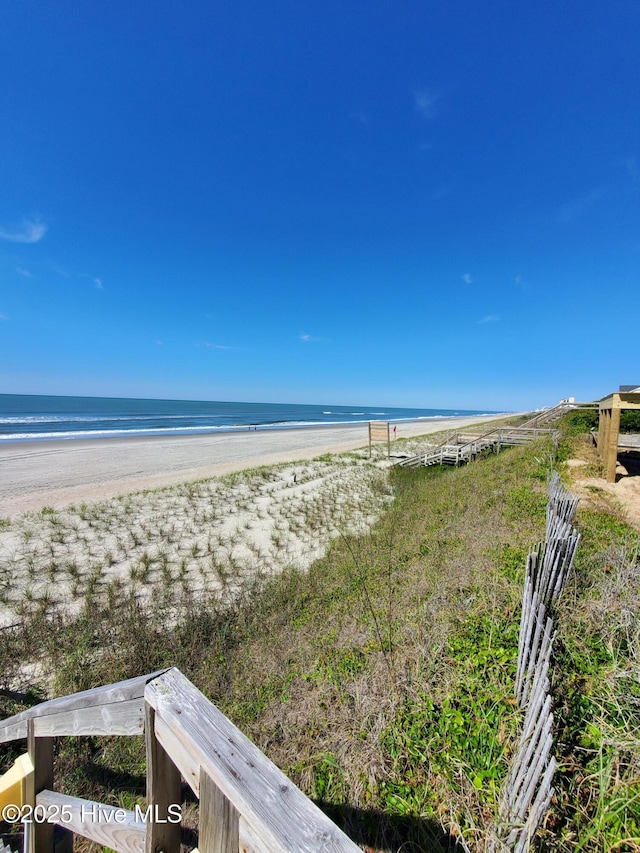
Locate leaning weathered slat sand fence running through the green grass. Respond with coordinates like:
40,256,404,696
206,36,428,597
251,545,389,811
494,472,580,853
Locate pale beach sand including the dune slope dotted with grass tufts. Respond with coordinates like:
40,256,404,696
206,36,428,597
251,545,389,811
0,416,512,627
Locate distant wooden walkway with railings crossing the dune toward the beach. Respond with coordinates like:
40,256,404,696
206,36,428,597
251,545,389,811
396,427,560,468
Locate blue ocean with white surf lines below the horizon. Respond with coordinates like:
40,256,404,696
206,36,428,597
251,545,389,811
0,394,500,442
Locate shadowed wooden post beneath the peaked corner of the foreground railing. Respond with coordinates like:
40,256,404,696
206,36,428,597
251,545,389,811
144,702,182,853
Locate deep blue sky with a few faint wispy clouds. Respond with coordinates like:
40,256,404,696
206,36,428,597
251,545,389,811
0,0,640,410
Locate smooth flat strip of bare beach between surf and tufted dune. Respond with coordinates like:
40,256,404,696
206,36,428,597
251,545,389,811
0,414,507,517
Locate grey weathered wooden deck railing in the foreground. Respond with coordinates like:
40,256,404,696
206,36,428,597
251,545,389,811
0,668,359,853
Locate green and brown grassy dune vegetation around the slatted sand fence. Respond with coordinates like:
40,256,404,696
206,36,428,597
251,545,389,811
0,422,640,853
